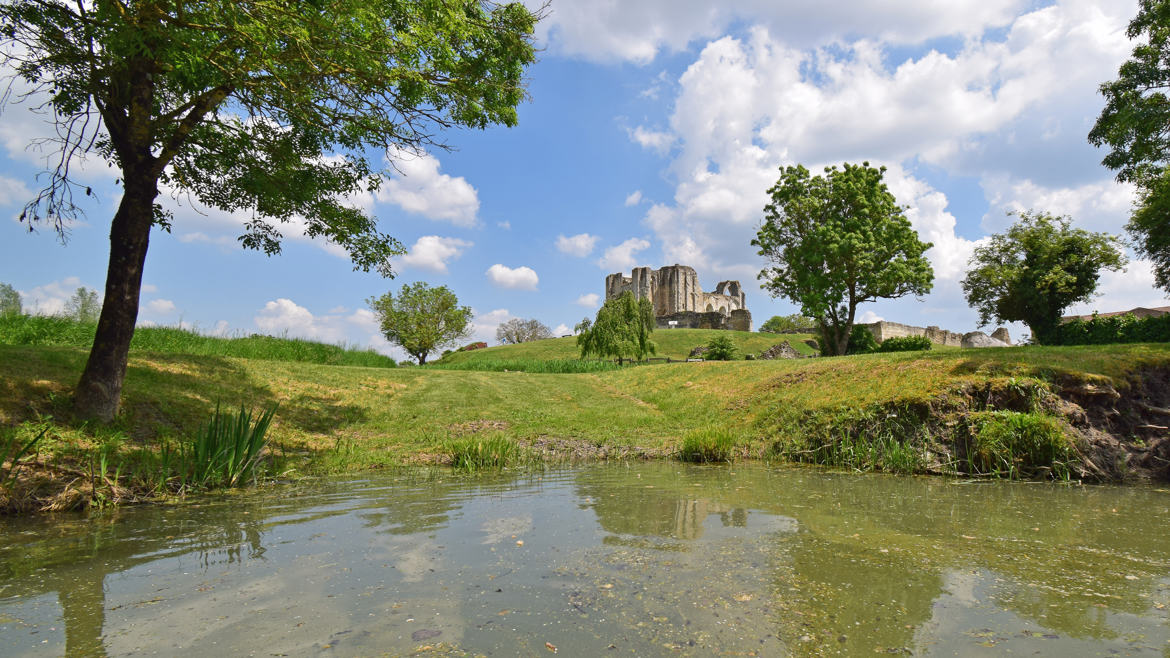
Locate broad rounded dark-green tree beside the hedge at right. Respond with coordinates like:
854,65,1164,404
963,211,1126,343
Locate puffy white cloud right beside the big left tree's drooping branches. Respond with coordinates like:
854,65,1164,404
377,150,480,226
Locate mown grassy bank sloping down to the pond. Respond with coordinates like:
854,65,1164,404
0,333,1170,507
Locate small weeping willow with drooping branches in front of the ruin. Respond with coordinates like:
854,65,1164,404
577,290,658,364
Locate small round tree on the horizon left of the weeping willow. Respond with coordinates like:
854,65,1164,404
366,281,472,365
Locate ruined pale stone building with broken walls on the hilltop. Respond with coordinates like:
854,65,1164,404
605,265,751,331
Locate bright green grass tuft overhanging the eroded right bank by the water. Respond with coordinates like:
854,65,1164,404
968,411,1076,480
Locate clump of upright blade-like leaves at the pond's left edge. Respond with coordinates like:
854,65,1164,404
183,405,276,487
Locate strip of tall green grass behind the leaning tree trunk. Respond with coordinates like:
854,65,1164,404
0,315,395,368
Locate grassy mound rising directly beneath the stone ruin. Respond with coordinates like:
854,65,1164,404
441,329,815,365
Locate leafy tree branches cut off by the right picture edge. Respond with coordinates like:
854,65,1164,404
1089,0,1170,290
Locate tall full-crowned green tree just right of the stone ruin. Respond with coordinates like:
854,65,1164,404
751,163,934,355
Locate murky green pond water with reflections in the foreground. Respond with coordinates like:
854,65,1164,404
0,464,1170,657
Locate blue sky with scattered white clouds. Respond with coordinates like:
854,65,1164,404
0,0,1170,358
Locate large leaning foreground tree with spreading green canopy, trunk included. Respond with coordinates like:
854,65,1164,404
0,0,538,419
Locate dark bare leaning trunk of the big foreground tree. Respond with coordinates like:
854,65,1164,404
74,176,158,423
